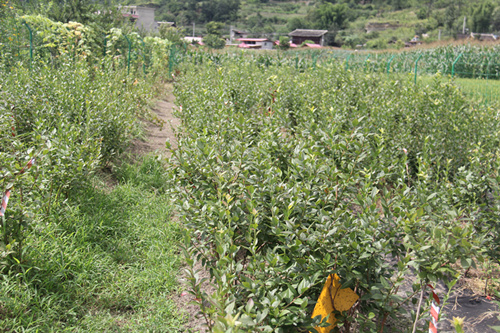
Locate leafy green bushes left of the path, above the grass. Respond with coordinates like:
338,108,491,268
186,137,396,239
0,56,156,264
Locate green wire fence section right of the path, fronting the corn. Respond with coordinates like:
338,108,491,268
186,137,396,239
196,44,500,104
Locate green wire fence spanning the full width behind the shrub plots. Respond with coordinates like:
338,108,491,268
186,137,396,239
0,13,500,104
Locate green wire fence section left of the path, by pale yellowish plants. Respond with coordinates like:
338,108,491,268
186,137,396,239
0,18,186,75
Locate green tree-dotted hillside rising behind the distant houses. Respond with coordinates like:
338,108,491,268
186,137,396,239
18,0,500,49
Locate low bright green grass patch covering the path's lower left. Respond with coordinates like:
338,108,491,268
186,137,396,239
0,157,184,332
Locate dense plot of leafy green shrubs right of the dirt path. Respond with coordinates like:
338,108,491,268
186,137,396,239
170,59,500,332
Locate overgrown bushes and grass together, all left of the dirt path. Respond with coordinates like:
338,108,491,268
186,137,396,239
0,1,188,332
